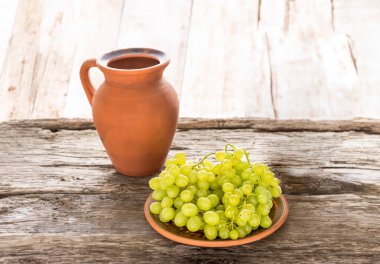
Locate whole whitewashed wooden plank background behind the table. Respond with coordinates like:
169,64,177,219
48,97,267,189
0,0,380,120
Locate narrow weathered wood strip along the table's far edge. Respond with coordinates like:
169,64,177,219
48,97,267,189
4,118,380,134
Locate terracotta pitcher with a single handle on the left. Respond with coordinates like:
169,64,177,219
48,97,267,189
80,48,178,176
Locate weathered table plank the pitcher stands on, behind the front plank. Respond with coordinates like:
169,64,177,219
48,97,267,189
0,119,380,197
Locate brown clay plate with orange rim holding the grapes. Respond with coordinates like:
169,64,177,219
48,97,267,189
144,195,289,247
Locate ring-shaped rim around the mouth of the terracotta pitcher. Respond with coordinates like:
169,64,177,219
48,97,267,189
96,48,170,74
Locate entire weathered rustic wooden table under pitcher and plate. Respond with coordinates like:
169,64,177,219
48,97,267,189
0,119,380,263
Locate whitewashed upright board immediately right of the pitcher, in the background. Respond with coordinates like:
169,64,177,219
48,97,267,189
180,0,274,118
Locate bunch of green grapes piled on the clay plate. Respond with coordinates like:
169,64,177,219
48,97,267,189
149,144,282,240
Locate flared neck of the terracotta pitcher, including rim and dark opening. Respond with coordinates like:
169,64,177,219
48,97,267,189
96,48,170,86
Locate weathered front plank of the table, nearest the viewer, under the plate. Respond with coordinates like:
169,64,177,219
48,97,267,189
0,194,380,263
